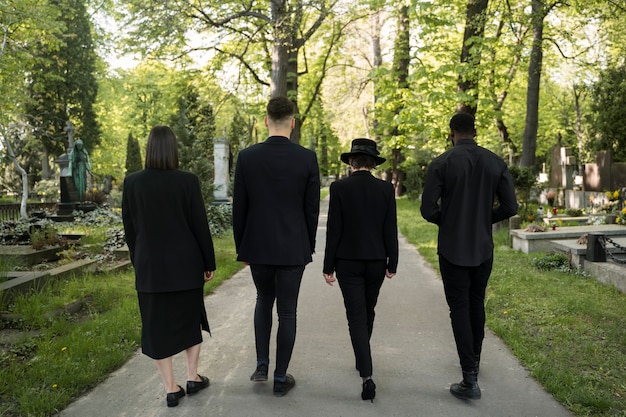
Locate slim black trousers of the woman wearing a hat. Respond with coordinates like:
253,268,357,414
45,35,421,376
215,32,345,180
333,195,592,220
335,259,386,377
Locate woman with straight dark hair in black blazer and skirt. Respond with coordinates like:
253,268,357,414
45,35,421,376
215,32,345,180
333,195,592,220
122,126,215,407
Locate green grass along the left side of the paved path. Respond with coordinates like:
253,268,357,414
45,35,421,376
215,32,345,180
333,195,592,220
0,235,242,416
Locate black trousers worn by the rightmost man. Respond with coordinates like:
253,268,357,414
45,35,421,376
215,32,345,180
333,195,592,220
439,255,493,372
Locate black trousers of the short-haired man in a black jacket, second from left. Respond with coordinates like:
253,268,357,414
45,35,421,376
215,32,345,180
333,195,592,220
250,265,304,378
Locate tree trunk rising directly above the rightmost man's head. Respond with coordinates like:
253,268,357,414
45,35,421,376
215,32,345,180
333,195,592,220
457,0,489,115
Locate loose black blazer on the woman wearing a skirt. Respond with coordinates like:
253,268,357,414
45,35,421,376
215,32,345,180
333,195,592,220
122,169,215,292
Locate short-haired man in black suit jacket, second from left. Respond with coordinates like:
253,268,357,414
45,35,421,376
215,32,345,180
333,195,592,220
233,97,320,397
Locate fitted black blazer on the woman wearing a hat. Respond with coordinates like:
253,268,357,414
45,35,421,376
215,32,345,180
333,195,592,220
323,171,398,274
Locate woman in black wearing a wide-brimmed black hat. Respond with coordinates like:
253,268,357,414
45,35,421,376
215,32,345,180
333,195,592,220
323,138,398,401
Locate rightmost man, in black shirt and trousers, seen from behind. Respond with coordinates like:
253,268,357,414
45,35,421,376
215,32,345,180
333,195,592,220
421,113,518,400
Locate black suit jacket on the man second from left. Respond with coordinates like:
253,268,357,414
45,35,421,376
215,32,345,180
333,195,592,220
233,136,320,265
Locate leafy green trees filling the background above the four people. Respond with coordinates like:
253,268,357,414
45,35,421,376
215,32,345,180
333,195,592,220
0,0,626,205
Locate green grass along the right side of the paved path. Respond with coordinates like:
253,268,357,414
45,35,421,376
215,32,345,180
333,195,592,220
398,199,626,416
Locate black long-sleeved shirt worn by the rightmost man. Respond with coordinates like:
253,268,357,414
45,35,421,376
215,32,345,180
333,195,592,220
420,139,517,267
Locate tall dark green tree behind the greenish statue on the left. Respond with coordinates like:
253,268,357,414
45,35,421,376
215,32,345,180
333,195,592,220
26,0,100,178
